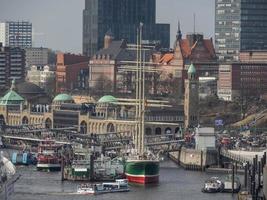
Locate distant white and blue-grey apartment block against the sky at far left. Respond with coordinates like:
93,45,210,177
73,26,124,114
0,21,32,48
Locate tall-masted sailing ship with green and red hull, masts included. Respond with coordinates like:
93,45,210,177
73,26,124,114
125,23,159,184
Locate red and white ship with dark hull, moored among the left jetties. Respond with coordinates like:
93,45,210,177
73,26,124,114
37,140,61,171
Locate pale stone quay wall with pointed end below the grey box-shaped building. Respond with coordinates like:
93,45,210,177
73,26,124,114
169,148,217,170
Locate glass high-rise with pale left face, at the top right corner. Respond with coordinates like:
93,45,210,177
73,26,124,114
215,0,267,61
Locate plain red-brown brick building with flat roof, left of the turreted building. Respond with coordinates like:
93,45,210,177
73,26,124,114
56,53,89,92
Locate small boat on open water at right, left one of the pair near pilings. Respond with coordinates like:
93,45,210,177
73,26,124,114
202,177,224,193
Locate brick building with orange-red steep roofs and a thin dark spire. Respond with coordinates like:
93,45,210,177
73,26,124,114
159,26,218,95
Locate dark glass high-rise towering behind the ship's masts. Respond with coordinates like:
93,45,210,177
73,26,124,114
83,0,170,56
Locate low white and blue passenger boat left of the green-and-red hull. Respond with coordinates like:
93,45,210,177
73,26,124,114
77,179,130,194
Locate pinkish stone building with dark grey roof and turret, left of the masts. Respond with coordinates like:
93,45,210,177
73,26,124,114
89,32,140,93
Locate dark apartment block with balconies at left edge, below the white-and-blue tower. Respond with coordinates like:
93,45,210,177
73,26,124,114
0,43,25,88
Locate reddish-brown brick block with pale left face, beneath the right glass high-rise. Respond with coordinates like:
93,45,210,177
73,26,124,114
218,51,267,101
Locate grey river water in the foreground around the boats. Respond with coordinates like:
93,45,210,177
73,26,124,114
12,161,240,200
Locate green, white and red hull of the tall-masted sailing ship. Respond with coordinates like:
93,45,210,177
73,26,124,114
125,159,159,184
